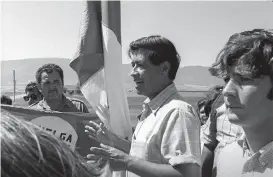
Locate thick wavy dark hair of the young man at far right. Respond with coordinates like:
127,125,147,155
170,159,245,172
210,29,273,81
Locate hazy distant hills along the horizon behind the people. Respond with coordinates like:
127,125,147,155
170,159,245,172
1,58,223,90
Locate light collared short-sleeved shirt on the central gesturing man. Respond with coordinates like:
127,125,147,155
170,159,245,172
127,84,201,177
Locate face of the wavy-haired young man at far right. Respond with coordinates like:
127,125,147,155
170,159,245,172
223,74,273,127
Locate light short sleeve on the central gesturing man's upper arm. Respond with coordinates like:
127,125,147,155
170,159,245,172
161,106,201,166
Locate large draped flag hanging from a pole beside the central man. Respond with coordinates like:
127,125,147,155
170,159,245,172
70,1,132,139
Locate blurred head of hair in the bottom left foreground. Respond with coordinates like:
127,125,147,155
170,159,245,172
0,111,104,177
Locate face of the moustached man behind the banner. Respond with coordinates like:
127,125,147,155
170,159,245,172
40,70,63,101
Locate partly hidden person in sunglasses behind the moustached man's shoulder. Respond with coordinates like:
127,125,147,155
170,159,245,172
23,82,43,106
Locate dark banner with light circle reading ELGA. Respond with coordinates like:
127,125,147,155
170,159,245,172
1,105,100,157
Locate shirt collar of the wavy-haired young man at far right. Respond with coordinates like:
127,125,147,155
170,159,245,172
237,136,273,167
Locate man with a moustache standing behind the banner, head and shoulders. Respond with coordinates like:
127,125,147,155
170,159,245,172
29,64,88,113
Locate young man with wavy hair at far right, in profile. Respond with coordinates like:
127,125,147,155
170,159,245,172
209,29,273,177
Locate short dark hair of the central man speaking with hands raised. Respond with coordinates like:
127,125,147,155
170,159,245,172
128,35,180,80
